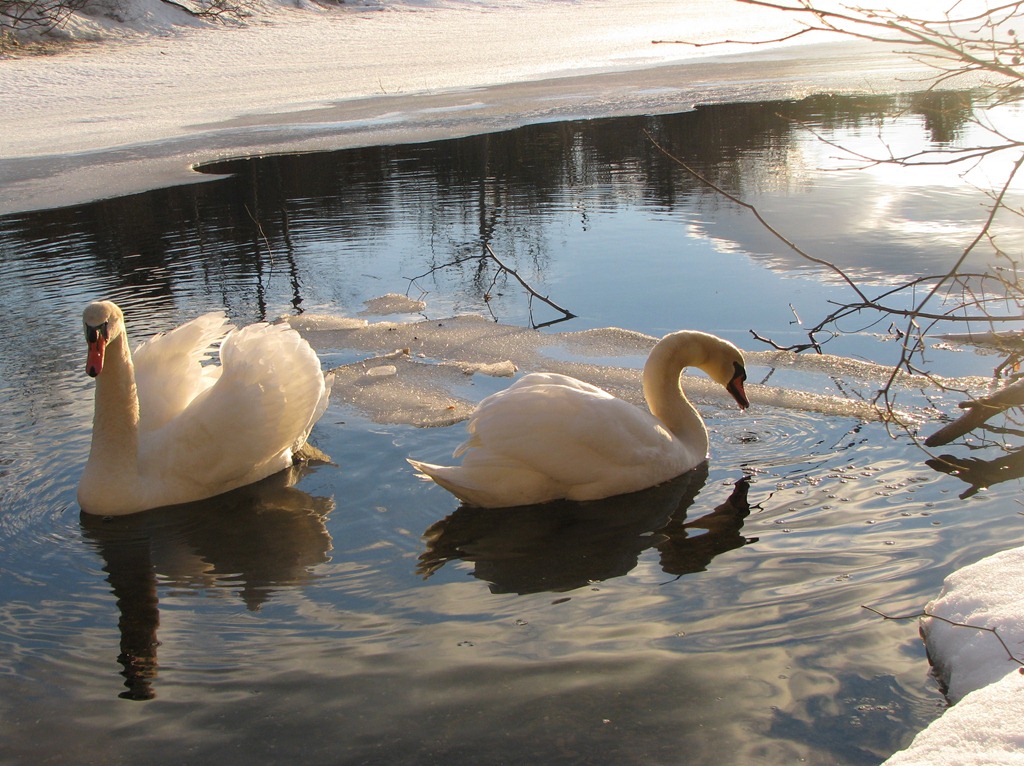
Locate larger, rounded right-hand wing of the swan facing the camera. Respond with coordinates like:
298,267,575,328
140,325,325,494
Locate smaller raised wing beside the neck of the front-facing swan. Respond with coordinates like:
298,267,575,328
132,311,233,431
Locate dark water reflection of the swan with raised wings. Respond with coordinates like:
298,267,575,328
81,464,334,699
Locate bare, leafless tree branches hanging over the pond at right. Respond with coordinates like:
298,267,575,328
648,0,1024,444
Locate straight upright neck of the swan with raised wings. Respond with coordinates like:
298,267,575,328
87,332,138,481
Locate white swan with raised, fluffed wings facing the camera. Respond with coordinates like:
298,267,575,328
78,301,331,516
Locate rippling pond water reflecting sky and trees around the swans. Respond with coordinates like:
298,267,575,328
0,93,1024,764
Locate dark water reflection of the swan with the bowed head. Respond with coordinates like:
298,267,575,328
417,464,756,594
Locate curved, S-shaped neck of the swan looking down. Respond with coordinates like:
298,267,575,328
643,333,709,455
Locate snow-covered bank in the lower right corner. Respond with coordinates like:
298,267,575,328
886,548,1024,766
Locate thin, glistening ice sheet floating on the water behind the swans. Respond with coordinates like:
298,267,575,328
289,303,966,426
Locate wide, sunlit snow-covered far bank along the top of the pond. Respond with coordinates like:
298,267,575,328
0,0,921,214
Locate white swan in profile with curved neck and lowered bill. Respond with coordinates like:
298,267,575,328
409,331,749,508
